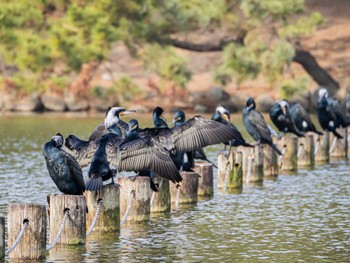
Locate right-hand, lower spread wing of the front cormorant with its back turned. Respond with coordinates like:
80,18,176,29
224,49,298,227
107,137,182,183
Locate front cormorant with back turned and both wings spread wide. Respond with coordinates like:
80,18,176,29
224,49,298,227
65,133,182,191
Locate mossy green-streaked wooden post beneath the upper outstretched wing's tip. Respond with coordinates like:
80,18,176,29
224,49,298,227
218,150,243,191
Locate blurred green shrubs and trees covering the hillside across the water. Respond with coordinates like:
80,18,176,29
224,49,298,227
0,0,322,99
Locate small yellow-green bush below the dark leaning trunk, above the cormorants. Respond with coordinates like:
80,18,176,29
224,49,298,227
278,76,310,99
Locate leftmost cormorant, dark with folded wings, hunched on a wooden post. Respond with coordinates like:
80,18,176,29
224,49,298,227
44,133,85,195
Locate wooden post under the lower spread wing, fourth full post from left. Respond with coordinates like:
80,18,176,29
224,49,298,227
118,176,152,223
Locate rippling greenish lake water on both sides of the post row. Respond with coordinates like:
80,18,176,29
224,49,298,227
0,115,350,262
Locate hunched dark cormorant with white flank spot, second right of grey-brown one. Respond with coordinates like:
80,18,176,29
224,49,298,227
289,102,323,135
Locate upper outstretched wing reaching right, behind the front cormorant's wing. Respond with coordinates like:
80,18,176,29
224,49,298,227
166,116,236,152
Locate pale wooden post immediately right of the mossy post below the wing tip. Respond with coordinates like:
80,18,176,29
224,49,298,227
237,145,264,183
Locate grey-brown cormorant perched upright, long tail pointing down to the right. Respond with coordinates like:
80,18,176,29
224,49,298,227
242,98,282,155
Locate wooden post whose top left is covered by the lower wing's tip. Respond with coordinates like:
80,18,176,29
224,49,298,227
170,172,199,205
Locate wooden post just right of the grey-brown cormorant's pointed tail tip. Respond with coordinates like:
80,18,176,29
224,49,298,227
277,134,298,172
